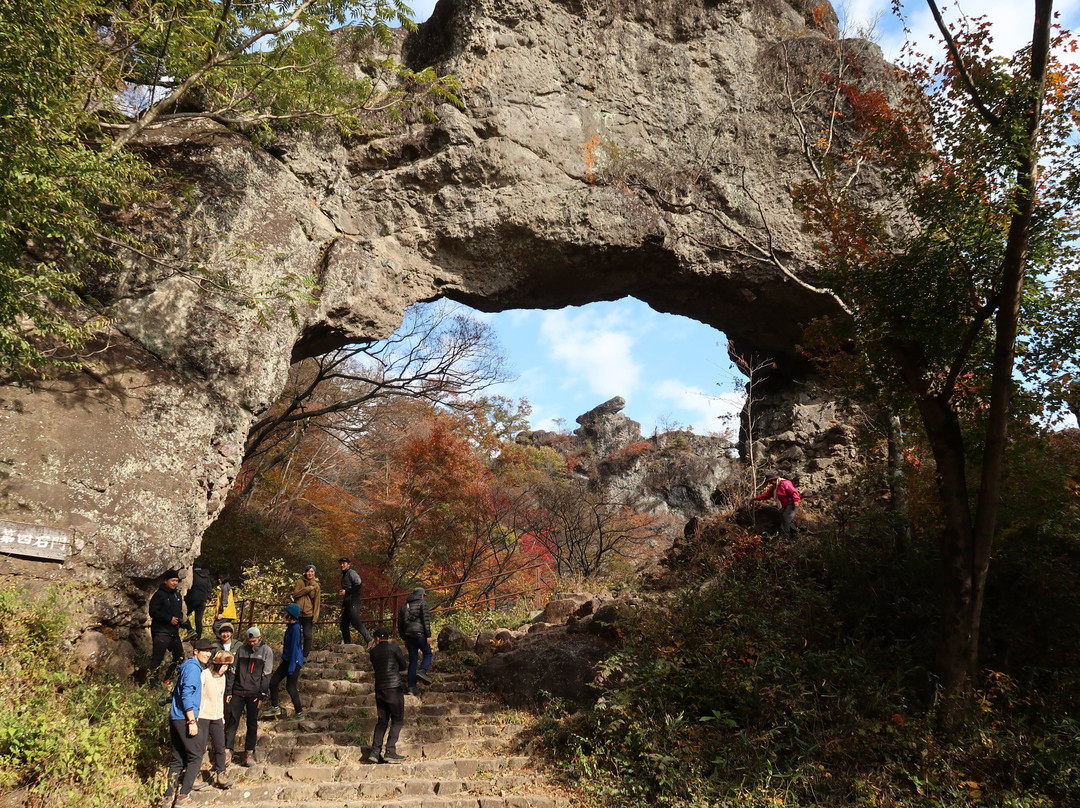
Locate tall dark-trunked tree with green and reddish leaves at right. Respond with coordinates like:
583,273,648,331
799,0,1080,731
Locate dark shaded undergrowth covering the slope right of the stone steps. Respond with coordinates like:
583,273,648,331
539,518,1080,808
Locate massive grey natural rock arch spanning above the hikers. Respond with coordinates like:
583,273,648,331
0,0,886,658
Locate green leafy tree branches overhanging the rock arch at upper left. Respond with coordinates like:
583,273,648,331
0,0,460,377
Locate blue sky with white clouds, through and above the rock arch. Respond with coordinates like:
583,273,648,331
413,0,1080,434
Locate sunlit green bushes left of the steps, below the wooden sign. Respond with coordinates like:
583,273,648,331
0,587,167,807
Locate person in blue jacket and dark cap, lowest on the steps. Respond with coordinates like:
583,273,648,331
162,639,214,806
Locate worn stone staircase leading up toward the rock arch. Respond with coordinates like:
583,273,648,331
185,645,570,808
